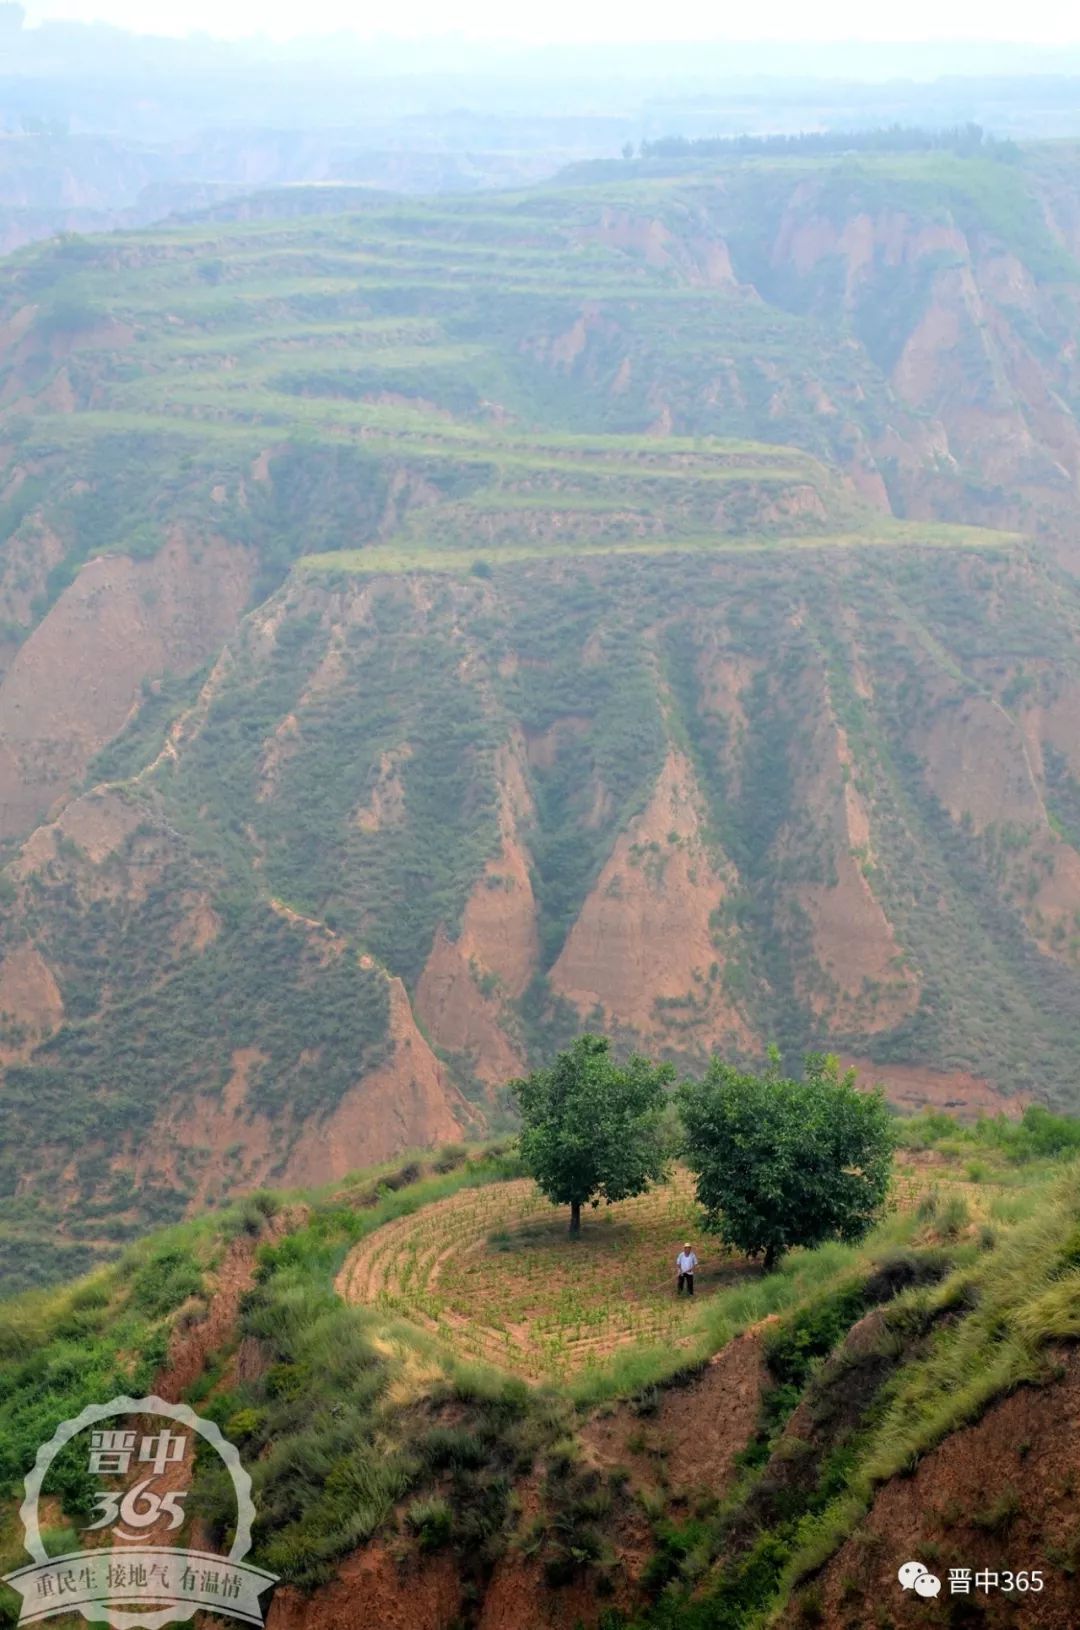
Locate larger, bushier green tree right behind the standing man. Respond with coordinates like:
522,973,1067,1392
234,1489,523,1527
679,1053,894,1271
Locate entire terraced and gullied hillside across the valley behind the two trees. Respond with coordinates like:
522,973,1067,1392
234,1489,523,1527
0,150,1080,1283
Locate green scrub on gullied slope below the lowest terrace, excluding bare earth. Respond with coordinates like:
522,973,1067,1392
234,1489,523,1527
10,547,1080,1283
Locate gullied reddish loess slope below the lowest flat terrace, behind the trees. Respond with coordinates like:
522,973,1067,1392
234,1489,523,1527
0,534,1080,1284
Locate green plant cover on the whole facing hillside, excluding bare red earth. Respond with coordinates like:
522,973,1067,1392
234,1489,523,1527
0,140,1080,1283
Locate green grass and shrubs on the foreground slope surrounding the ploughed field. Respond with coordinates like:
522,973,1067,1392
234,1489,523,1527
0,1112,1080,1630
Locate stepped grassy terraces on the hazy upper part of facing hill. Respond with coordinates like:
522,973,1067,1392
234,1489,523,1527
0,155,1049,592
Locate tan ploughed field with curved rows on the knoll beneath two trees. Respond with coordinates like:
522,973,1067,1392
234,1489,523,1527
336,1134,1049,1384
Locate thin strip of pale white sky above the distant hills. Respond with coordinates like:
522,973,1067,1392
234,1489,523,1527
23,0,1080,44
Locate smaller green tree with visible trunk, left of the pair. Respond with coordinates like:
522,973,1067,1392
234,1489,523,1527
510,1035,674,1234
